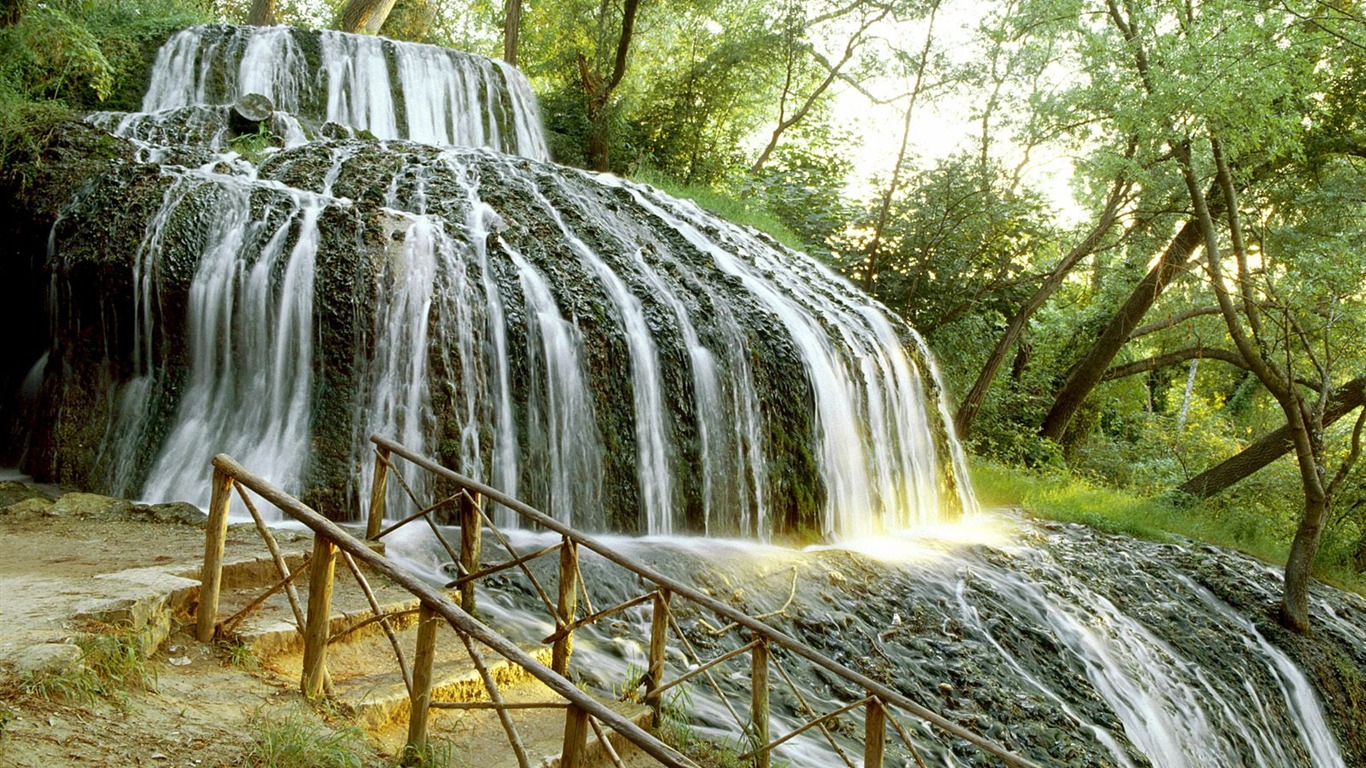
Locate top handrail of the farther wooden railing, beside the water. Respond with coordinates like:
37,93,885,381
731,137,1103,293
374,435,1041,768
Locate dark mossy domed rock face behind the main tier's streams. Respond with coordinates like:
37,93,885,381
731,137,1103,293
11,101,947,541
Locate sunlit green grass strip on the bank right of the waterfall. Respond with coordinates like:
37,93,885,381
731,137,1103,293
971,459,1366,596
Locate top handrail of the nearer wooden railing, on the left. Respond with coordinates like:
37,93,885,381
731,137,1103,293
213,454,699,768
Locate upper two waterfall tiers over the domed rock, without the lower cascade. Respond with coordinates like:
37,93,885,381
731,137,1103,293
49,26,974,538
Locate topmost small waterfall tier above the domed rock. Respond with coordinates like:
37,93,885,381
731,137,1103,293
129,26,549,160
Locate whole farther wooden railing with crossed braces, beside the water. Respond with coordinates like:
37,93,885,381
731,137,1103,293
363,435,1037,768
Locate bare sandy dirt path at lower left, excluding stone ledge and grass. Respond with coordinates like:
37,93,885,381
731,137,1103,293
0,481,389,768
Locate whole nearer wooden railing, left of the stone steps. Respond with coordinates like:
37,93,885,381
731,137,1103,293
195,454,698,768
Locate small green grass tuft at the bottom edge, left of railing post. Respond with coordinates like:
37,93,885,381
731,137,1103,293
246,712,370,768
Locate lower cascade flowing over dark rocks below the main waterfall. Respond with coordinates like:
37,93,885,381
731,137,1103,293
391,512,1366,768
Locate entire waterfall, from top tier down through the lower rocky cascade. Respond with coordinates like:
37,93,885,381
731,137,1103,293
15,26,1366,768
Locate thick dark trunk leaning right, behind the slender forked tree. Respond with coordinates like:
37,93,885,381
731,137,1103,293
1040,219,1201,443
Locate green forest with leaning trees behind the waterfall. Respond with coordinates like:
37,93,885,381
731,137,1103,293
0,0,1366,629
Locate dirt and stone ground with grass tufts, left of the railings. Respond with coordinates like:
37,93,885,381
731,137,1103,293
0,480,654,768
